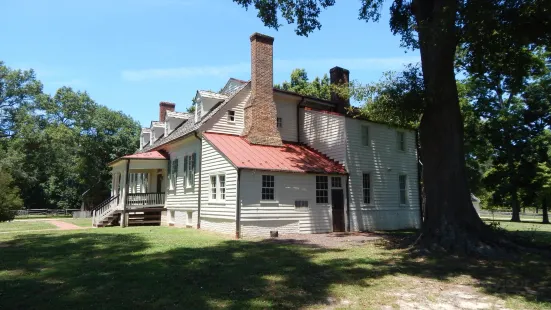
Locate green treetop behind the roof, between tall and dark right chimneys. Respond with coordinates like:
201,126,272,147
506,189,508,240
274,69,331,100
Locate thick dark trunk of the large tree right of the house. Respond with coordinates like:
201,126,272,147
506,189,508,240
413,0,485,253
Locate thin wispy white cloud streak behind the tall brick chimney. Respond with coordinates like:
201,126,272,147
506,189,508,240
121,56,419,82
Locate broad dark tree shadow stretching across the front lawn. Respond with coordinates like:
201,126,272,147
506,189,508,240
0,232,551,309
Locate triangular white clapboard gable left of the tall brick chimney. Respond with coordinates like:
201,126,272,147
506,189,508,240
203,86,251,135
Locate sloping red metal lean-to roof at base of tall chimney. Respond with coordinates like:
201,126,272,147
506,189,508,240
203,133,346,174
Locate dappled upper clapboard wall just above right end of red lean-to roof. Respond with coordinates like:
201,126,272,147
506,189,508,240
299,109,346,164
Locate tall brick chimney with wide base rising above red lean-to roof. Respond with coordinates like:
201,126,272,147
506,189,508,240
244,32,283,146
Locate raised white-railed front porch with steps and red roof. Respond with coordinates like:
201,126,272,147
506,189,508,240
92,151,168,227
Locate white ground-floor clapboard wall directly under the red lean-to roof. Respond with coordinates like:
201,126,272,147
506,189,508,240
240,170,346,237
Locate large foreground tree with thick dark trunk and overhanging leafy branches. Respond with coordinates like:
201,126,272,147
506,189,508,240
234,0,551,253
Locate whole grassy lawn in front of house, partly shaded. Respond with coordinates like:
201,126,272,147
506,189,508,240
0,227,551,309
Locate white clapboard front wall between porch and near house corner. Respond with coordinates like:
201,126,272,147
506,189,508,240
164,136,201,227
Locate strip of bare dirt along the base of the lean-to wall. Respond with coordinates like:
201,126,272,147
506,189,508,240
263,232,382,248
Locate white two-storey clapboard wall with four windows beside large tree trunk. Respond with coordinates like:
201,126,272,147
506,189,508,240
346,118,420,231
